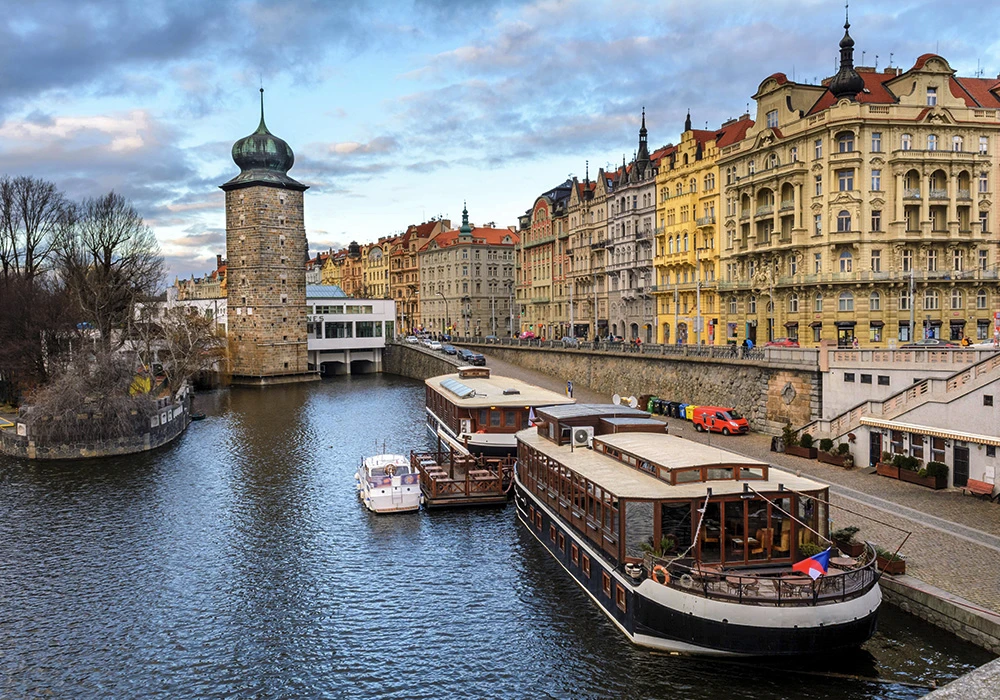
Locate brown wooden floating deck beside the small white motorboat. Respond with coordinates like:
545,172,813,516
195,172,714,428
410,450,514,508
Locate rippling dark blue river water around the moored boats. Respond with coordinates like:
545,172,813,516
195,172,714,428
0,375,991,699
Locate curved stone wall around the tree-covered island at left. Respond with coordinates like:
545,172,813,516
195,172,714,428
0,399,191,460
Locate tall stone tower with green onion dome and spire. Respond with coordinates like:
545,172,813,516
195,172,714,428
221,88,319,384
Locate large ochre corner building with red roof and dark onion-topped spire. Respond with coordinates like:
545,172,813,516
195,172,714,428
719,23,1000,346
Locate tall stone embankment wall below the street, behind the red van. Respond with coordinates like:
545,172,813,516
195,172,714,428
463,343,823,434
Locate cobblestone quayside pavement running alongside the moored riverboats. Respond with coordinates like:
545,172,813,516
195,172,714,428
478,358,1000,613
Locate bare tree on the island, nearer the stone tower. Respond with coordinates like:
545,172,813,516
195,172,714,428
58,192,163,350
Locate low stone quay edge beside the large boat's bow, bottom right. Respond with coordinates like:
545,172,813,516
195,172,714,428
879,576,1000,654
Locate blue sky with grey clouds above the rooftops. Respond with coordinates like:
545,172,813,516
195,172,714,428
0,0,1000,281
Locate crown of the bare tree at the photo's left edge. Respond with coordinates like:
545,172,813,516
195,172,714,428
0,176,73,282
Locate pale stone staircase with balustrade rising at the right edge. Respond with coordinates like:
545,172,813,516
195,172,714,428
796,353,1000,440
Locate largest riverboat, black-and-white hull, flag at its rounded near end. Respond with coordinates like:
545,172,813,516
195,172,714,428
515,405,882,656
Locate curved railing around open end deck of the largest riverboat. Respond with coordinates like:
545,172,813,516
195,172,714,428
643,544,878,607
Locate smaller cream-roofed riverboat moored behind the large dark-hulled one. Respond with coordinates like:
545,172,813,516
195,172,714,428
425,367,575,458
